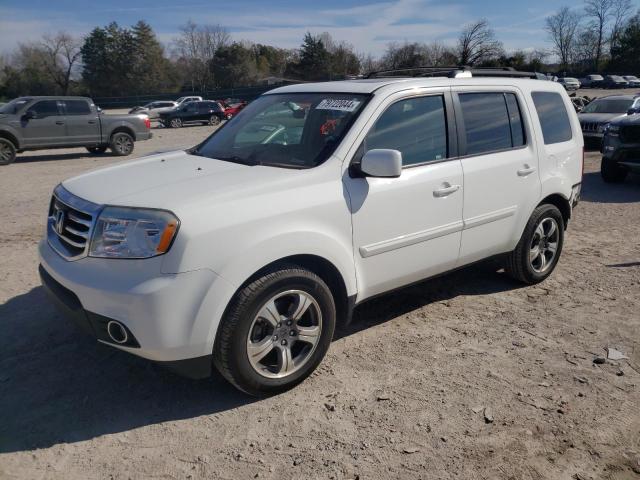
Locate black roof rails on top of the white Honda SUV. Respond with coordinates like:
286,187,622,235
366,65,546,79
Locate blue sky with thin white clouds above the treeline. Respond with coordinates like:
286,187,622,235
0,0,640,55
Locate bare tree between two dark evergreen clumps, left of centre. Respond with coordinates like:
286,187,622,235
174,20,231,91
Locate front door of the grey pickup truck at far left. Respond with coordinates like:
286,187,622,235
20,100,67,148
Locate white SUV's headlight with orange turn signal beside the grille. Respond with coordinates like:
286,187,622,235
89,207,180,258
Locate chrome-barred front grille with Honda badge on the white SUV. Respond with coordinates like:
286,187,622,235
47,185,101,260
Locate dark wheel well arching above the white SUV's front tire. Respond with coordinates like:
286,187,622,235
238,255,351,322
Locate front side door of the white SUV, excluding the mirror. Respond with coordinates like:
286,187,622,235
344,91,464,300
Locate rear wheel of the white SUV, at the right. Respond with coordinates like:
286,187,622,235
505,204,564,285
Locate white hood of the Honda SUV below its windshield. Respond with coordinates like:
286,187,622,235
62,151,300,211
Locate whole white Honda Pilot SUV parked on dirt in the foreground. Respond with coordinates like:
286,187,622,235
39,72,583,395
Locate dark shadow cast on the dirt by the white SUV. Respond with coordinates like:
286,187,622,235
0,262,519,452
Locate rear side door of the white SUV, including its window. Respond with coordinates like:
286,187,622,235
453,87,541,265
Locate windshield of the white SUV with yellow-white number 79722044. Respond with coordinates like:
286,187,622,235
191,93,368,168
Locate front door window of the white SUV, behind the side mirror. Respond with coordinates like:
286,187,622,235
364,95,447,165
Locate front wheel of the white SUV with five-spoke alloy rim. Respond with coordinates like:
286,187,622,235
213,266,336,396
